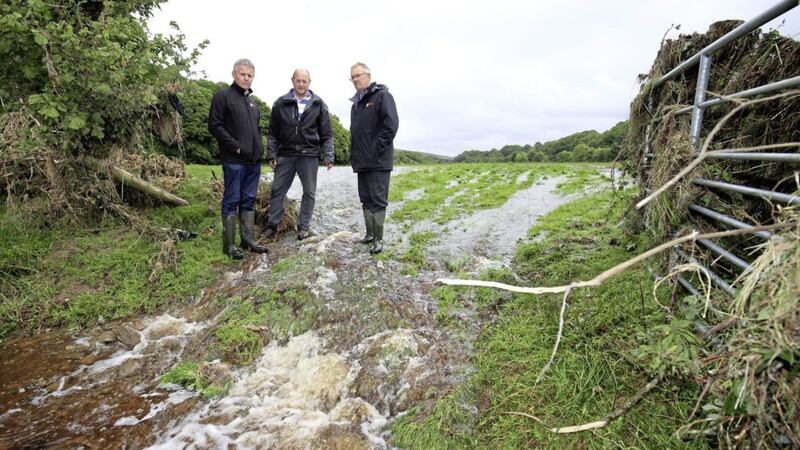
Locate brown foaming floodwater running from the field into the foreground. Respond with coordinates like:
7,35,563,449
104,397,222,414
0,168,580,449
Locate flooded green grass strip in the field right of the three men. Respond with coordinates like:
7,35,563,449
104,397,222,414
389,163,608,225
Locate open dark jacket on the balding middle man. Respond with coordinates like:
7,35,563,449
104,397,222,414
267,91,333,164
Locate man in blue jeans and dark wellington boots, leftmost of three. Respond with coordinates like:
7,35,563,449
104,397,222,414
208,59,267,259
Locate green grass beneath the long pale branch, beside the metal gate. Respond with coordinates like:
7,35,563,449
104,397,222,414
392,192,707,449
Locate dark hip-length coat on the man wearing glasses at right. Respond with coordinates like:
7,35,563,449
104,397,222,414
350,83,399,172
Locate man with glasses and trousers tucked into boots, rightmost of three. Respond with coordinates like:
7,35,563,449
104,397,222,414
350,63,399,254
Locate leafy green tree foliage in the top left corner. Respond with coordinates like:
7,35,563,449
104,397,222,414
0,0,207,156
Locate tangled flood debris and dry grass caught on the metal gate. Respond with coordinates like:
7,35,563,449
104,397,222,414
626,21,800,448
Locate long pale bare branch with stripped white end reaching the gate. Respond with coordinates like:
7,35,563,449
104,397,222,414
436,222,800,294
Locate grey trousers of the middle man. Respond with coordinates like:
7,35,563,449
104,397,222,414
267,156,319,230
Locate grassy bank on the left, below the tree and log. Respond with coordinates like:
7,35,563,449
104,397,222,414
0,166,244,339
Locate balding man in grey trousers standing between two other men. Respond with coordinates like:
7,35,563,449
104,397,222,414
264,69,333,240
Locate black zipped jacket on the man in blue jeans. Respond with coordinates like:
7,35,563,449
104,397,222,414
208,83,264,164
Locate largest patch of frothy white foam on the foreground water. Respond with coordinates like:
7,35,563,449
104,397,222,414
150,331,386,450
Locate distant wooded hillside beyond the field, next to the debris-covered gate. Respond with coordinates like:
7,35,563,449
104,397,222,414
453,120,628,162
